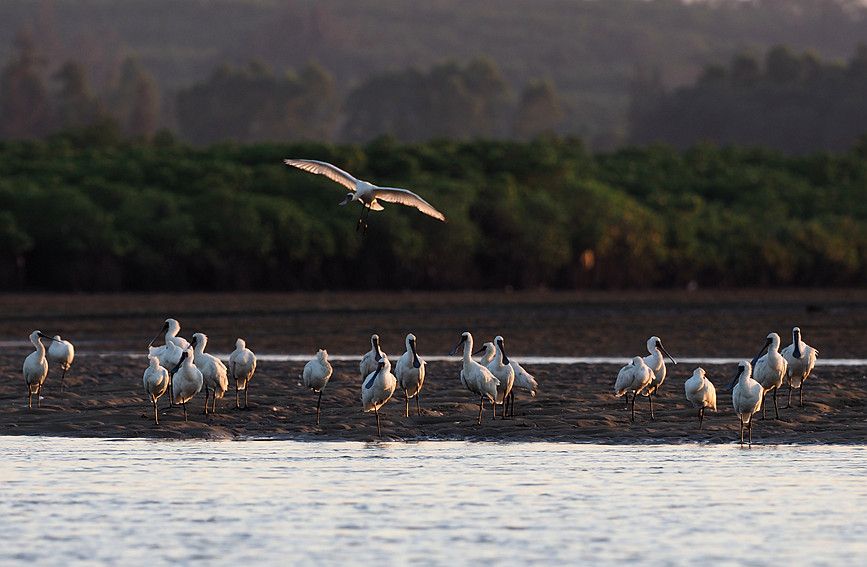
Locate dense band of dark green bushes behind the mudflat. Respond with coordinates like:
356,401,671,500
0,130,867,290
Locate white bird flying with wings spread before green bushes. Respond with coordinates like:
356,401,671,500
283,159,446,234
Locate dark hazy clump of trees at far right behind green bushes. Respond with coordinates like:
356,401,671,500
629,43,867,153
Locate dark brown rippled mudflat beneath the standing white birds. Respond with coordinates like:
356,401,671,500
0,292,867,444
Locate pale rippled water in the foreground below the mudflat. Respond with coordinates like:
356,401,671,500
0,437,867,566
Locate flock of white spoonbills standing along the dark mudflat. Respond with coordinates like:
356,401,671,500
23,318,819,444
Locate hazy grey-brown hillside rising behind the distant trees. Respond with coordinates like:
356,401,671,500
0,0,867,149
